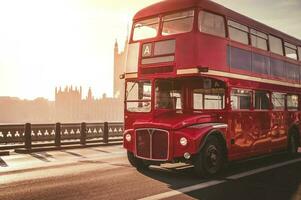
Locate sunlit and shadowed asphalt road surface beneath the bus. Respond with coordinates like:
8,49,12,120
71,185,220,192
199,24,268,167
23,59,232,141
0,146,301,200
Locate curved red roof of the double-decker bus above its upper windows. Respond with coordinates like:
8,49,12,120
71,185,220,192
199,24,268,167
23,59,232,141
134,0,301,46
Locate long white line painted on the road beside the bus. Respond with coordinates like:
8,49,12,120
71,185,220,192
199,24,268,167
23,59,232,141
139,158,301,200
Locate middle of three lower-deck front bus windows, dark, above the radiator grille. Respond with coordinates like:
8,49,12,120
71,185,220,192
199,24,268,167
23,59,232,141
155,80,182,110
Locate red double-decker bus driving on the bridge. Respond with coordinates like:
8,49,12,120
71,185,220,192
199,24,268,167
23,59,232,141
124,0,301,176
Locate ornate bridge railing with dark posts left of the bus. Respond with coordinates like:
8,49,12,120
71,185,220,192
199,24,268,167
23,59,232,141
0,122,123,150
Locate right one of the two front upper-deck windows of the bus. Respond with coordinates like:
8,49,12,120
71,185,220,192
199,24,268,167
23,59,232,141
162,10,194,36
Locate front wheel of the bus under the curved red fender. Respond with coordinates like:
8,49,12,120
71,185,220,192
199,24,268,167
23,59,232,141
194,136,224,178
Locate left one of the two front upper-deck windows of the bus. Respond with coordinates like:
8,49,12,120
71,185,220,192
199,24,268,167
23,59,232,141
133,17,159,41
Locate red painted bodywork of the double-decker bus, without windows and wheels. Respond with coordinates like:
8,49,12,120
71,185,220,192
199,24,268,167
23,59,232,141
124,0,301,166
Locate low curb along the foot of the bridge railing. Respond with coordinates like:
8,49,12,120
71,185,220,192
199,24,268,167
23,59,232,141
15,142,123,154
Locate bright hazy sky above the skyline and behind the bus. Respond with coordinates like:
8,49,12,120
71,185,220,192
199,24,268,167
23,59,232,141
0,0,301,99
